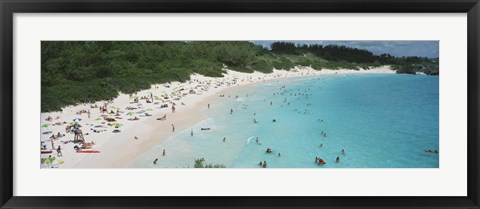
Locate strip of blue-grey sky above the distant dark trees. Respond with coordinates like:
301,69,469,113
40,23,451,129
253,41,439,58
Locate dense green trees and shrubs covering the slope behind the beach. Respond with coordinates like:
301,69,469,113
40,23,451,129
41,41,438,112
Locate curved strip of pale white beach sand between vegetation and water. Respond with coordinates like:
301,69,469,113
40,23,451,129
41,66,395,168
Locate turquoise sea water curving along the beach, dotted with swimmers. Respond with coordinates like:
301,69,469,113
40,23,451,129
132,74,439,168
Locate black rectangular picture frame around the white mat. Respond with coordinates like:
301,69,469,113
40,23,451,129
0,0,480,209
